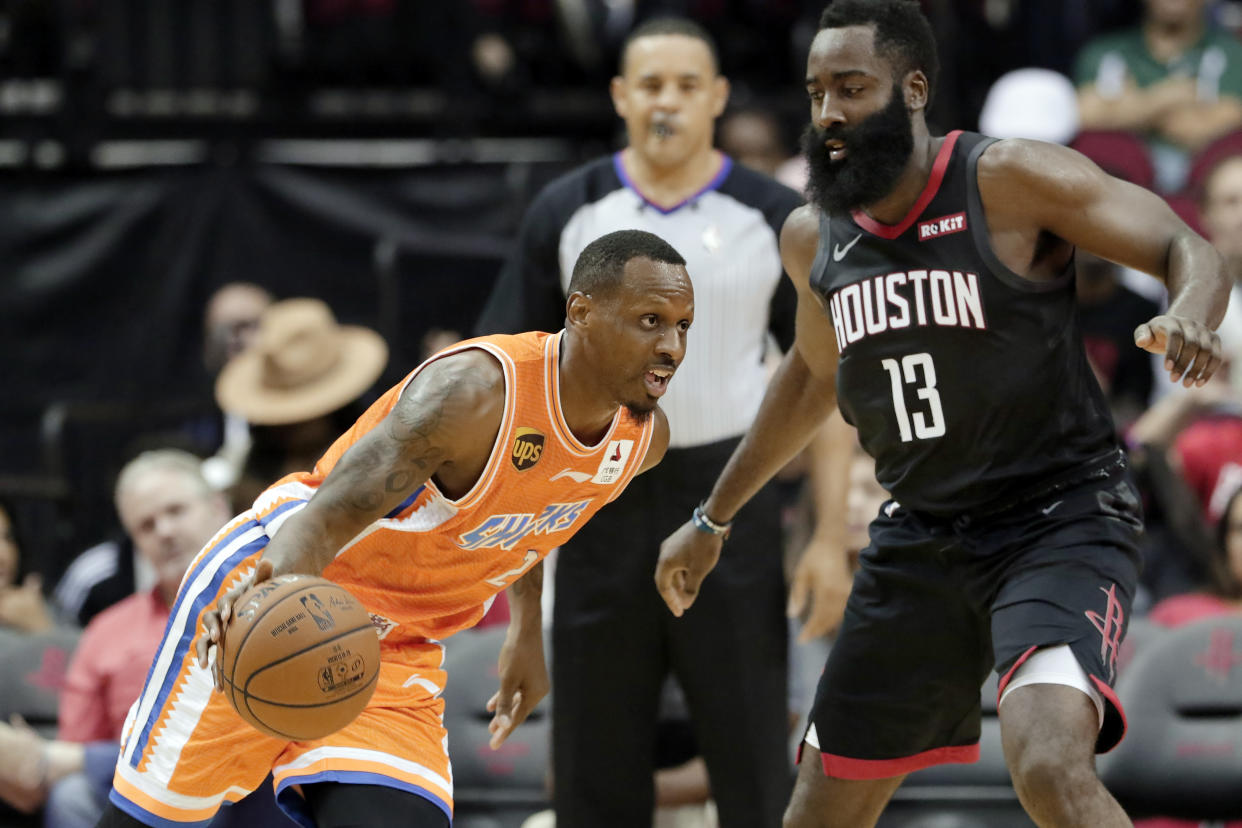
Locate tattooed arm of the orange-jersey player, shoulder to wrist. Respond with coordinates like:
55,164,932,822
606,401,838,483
265,350,504,575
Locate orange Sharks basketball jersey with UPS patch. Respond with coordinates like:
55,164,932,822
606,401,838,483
255,333,653,643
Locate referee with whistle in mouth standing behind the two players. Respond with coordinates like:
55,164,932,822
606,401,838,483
477,19,801,828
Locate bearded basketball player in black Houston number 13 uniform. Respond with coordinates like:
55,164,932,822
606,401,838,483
656,0,1228,828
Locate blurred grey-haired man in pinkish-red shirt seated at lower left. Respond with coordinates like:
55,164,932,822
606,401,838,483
0,449,229,828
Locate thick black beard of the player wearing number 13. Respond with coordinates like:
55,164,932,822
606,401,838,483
802,86,914,215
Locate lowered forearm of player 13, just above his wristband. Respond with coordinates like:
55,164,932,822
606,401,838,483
705,348,836,523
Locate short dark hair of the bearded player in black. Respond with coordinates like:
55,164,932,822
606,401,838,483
820,0,940,107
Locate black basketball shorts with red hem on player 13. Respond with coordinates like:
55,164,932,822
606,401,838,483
810,459,1143,780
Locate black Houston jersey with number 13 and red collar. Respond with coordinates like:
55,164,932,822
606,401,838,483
811,133,1118,514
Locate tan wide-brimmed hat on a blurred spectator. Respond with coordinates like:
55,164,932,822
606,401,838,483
216,299,388,426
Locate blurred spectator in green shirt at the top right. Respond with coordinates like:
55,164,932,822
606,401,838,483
1074,0,1242,192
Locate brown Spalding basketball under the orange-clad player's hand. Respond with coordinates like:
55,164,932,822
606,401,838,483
219,575,380,741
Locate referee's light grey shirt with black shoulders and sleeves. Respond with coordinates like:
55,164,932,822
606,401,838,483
476,153,802,448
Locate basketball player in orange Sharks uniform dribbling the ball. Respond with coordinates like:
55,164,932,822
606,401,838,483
99,230,694,828
